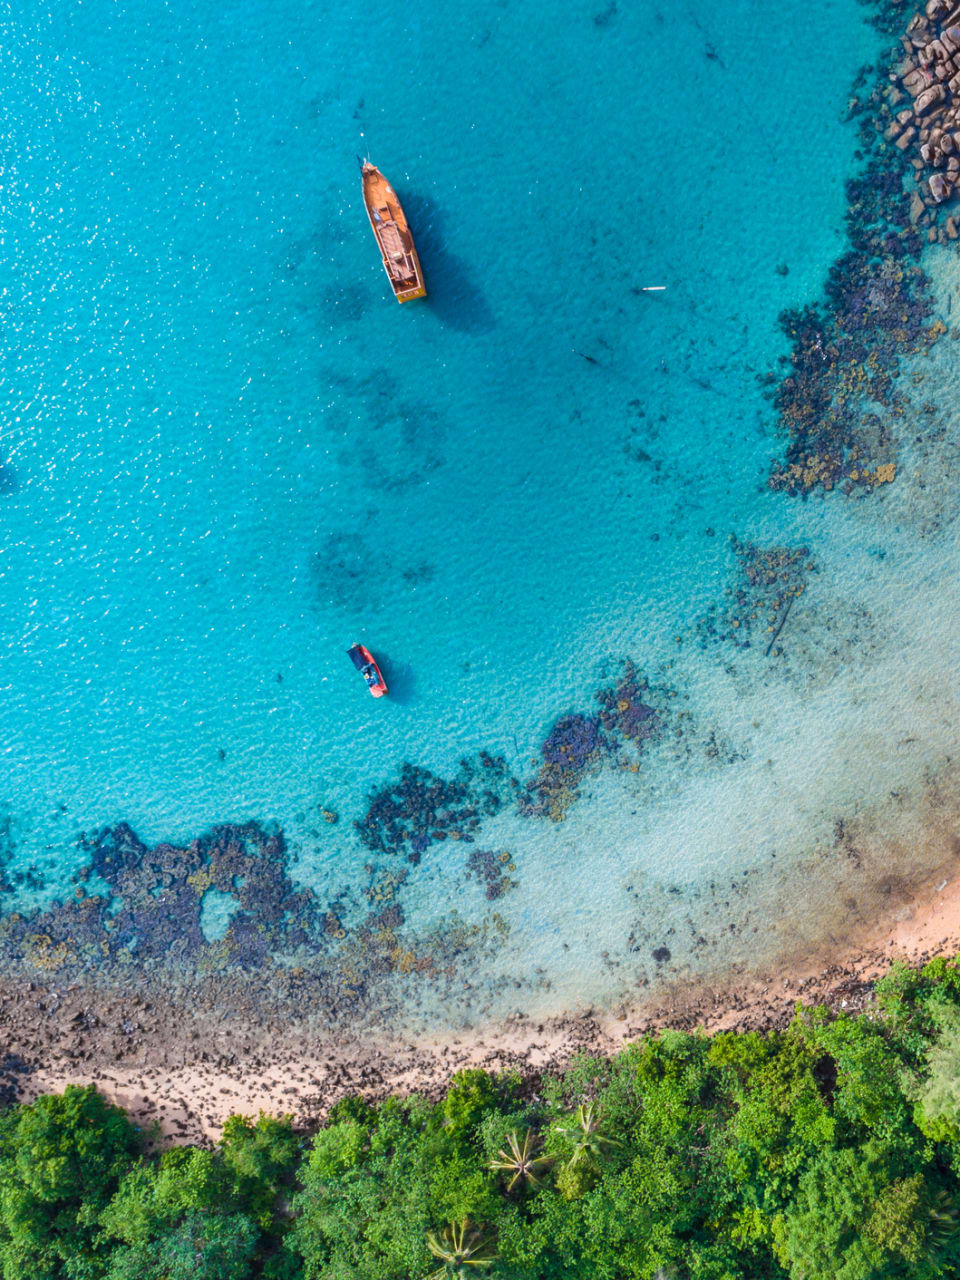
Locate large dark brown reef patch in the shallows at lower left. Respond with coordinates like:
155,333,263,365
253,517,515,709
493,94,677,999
0,823,507,1019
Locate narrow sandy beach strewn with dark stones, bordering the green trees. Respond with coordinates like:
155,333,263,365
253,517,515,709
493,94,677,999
13,872,960,1143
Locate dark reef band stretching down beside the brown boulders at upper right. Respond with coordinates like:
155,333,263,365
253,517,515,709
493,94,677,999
765,0,960,494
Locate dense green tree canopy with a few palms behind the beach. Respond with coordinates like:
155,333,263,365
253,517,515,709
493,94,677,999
7,960,960,1280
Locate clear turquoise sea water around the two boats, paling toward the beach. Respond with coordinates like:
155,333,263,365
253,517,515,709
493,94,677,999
0,0,956,1025
